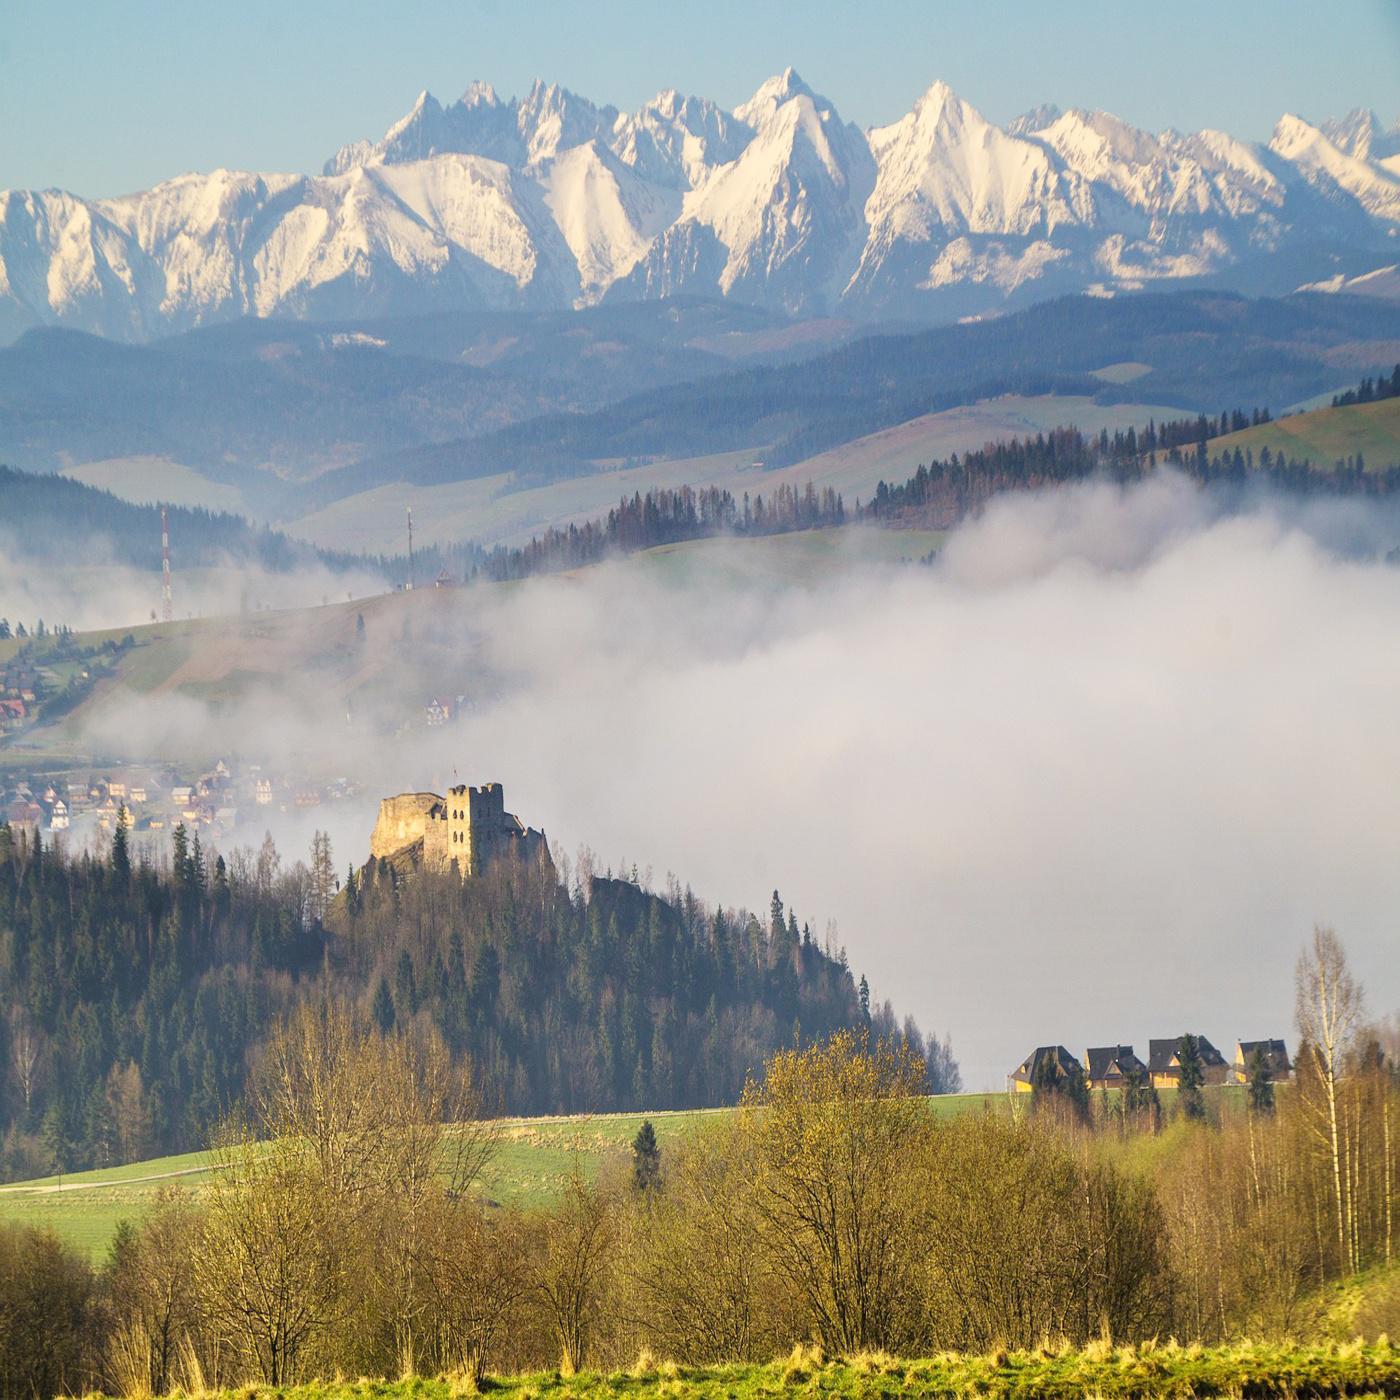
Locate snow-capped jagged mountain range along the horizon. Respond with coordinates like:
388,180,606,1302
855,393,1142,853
0,69,1400,340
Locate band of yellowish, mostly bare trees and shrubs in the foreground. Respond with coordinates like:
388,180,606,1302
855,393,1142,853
0,932,1400,1396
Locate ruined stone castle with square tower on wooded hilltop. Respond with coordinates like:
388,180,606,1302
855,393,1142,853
370,783,549,879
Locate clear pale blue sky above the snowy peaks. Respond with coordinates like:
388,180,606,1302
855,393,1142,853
0,0,1400,195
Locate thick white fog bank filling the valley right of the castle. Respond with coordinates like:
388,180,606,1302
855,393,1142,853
19,479,1400,1088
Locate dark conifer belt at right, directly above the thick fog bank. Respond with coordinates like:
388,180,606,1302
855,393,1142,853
857,414,1400,529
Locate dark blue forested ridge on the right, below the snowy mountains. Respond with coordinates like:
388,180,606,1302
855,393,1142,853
298,293,1394,510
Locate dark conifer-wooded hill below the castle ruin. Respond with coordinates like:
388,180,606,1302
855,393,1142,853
0,826,958,1180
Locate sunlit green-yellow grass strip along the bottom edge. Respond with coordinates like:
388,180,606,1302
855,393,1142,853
73,1341,1400,1400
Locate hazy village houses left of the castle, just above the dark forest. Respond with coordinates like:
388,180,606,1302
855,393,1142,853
0,759,360,836
